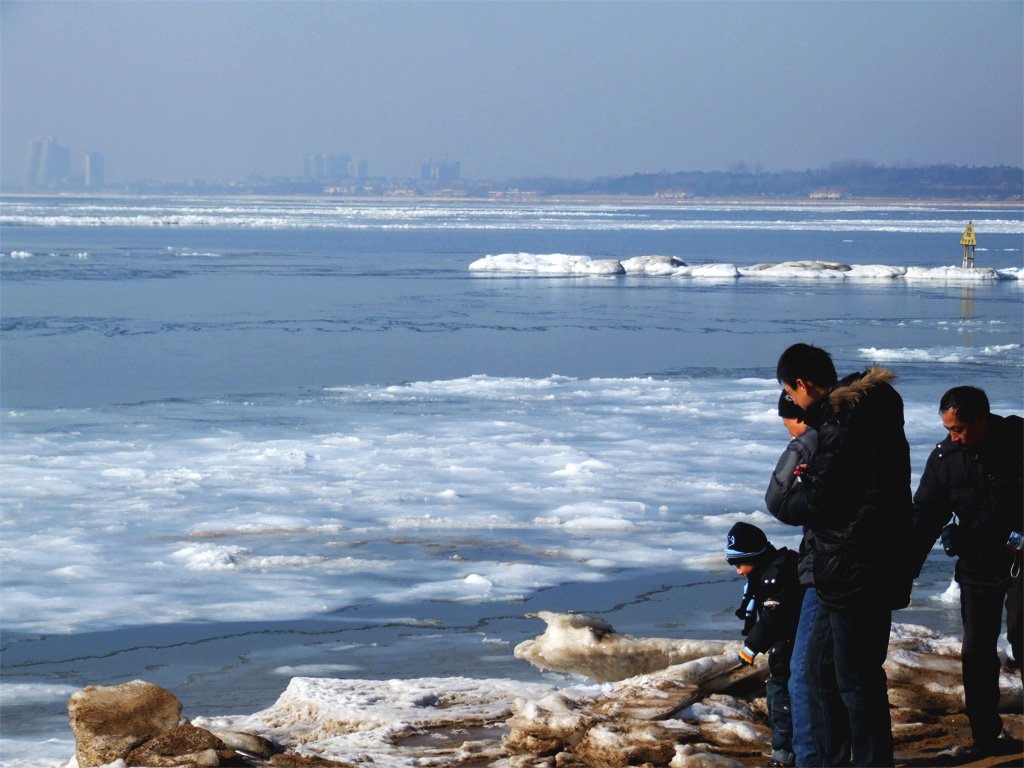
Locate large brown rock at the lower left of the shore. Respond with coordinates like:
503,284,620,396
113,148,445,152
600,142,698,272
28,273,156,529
68,680,185,768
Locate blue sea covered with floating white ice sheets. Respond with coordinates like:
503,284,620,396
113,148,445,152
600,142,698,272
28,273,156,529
0,197,1024,766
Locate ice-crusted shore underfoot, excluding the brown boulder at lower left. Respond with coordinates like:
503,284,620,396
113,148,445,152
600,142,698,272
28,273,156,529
180,612,1024,768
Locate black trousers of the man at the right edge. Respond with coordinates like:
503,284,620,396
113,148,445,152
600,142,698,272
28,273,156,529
961,575,1024,748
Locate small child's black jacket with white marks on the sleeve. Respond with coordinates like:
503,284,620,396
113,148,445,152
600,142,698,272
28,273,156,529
736,547,804,653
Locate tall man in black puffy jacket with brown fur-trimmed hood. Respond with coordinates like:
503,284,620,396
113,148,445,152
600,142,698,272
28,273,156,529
775,344,911,766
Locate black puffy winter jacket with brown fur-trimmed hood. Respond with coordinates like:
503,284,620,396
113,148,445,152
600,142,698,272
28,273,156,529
775,368,912,611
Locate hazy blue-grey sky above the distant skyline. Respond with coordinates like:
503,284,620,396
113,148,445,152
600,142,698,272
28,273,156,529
0,0,1024,184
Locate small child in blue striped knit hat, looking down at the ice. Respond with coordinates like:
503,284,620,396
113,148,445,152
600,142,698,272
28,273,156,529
725,522,803,766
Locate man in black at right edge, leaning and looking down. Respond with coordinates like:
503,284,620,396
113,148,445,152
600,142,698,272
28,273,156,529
913,387,1024,757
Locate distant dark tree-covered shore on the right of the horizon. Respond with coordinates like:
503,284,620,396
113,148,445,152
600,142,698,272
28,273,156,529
509,163,1024,200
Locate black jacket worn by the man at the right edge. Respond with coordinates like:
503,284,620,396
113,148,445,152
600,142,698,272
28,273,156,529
913,414,1024,586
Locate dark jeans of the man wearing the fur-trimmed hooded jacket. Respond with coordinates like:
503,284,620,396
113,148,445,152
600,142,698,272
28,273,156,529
804,605,893,766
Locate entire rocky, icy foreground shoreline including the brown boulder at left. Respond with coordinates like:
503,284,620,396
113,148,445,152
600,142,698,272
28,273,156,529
69,611,1024,768
